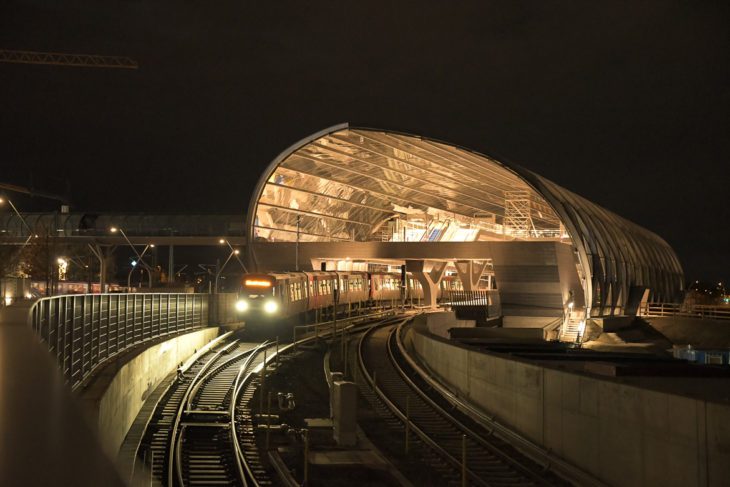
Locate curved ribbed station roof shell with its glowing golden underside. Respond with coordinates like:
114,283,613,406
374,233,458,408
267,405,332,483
247,124,683,314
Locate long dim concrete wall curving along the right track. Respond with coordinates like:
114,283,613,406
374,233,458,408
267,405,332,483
411,314,730,486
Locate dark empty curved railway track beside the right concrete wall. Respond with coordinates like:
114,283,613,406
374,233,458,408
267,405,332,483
358,324,569,486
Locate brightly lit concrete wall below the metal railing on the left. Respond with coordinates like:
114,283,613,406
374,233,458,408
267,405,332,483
81,327,219,458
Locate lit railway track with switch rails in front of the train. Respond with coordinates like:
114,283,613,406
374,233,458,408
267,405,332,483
138,341,272,487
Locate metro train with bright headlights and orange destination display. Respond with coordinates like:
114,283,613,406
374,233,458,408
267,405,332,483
235,271,470,336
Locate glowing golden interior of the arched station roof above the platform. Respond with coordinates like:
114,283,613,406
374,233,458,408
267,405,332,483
255,128,565,241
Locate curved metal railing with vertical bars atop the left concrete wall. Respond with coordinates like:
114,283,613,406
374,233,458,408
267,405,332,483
29,294,209,388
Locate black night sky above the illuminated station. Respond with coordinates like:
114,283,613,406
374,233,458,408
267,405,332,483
0,0,730,279
